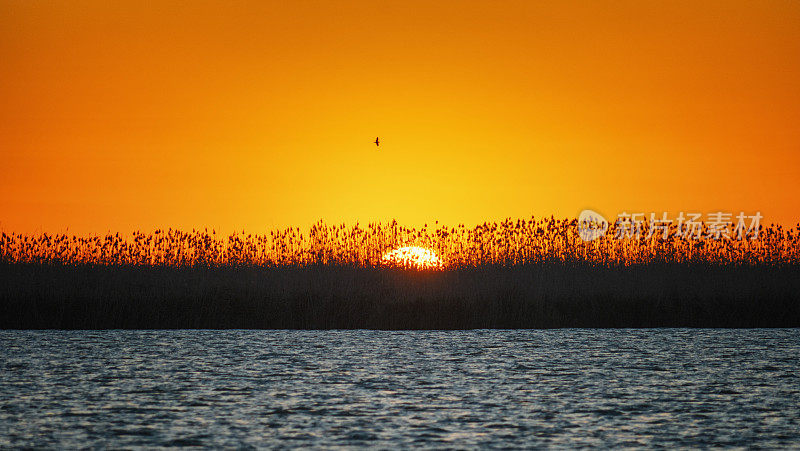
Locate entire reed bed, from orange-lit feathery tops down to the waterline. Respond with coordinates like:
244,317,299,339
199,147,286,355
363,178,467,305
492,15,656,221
0,217,800,329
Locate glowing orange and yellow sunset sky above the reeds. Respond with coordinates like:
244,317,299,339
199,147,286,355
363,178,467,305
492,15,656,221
0,0,800,233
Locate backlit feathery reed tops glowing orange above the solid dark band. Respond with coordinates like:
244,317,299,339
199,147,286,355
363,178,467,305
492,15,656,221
0,217,800,269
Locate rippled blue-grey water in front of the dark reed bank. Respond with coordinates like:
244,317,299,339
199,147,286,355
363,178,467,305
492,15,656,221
0,329,800,448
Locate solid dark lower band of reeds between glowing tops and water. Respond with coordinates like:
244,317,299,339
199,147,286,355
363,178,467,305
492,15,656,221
0,262,800,330
